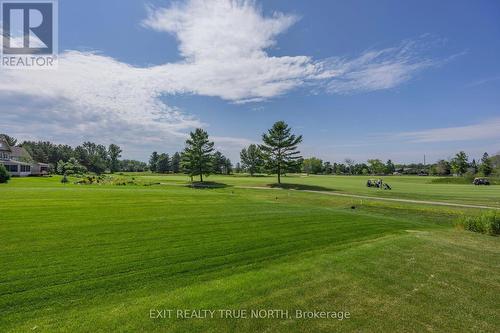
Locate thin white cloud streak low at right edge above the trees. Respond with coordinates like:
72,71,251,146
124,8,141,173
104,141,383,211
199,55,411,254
396,118,500,143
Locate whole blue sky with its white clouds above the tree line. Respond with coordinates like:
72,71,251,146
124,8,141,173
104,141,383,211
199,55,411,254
0,0,500,162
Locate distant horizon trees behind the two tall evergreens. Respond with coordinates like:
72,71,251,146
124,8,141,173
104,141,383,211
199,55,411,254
0,130,500,176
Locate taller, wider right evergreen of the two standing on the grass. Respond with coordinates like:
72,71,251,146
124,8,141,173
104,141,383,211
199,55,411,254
259,121,302,184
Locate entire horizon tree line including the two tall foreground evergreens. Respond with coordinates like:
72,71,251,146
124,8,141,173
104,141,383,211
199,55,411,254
0,125,500,183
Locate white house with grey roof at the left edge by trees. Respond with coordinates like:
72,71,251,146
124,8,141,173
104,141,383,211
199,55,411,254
0,137,49,177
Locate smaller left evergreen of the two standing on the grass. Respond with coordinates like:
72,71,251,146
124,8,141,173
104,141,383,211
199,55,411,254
182,128,214,182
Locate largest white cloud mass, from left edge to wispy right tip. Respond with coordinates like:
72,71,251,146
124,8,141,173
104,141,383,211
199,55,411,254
0,0,446,160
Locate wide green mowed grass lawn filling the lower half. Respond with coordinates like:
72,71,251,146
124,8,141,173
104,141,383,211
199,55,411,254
0,175,500,332
